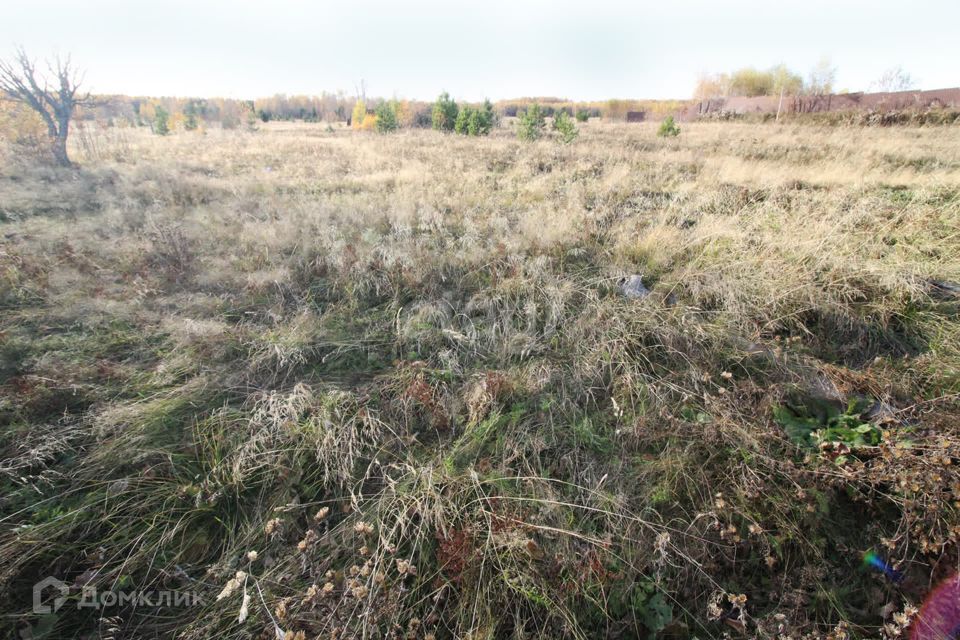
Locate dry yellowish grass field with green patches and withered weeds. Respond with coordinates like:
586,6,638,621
0,122,960,640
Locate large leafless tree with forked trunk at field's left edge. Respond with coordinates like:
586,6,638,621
0,48,90,167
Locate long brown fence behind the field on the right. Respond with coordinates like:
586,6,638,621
678,88,960,120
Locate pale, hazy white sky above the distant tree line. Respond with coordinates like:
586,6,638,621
0,0,960,100
